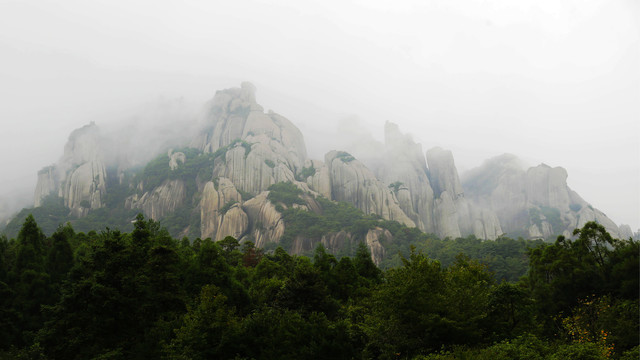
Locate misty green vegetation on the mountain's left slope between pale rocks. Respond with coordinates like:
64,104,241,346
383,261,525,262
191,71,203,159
3,148,220,237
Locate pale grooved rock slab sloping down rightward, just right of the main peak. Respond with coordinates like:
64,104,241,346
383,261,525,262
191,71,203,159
325,151,415,227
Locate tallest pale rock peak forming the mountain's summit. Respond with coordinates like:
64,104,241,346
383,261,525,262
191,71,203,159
191,83,307,195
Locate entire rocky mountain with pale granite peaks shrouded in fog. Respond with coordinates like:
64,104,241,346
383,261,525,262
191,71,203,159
6,83,632,261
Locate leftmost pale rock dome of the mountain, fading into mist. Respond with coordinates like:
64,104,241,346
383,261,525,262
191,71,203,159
34,123,107,216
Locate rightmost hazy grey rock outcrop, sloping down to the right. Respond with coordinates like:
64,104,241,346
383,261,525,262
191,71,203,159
463,154,620,238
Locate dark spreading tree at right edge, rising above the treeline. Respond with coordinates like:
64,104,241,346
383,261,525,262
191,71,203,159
525,222,638,350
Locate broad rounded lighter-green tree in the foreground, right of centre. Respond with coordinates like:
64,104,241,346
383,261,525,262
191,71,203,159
365,252,492,359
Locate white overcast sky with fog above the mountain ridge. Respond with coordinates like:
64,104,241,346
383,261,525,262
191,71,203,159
0,0,640,230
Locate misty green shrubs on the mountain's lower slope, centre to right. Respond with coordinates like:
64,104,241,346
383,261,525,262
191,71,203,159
267,182,542,281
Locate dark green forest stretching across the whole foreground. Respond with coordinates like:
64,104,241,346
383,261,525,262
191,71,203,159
0,215,640,360
